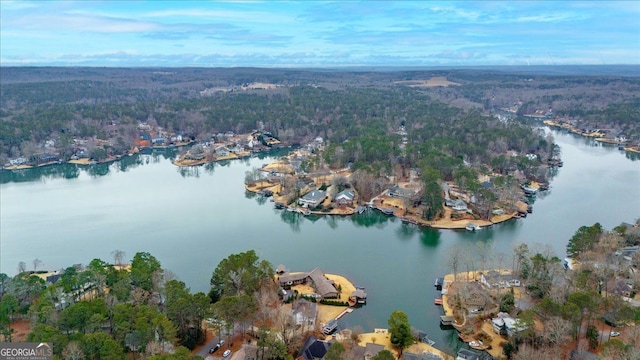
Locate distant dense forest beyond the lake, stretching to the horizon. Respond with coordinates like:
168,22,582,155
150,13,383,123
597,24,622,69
0,67,640,166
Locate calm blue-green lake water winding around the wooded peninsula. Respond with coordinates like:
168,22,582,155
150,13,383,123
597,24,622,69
0,132,640,352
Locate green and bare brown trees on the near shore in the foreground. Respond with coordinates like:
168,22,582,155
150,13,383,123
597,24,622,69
0,222,640,360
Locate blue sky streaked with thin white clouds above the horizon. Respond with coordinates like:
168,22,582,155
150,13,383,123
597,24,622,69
0,0,640,67
